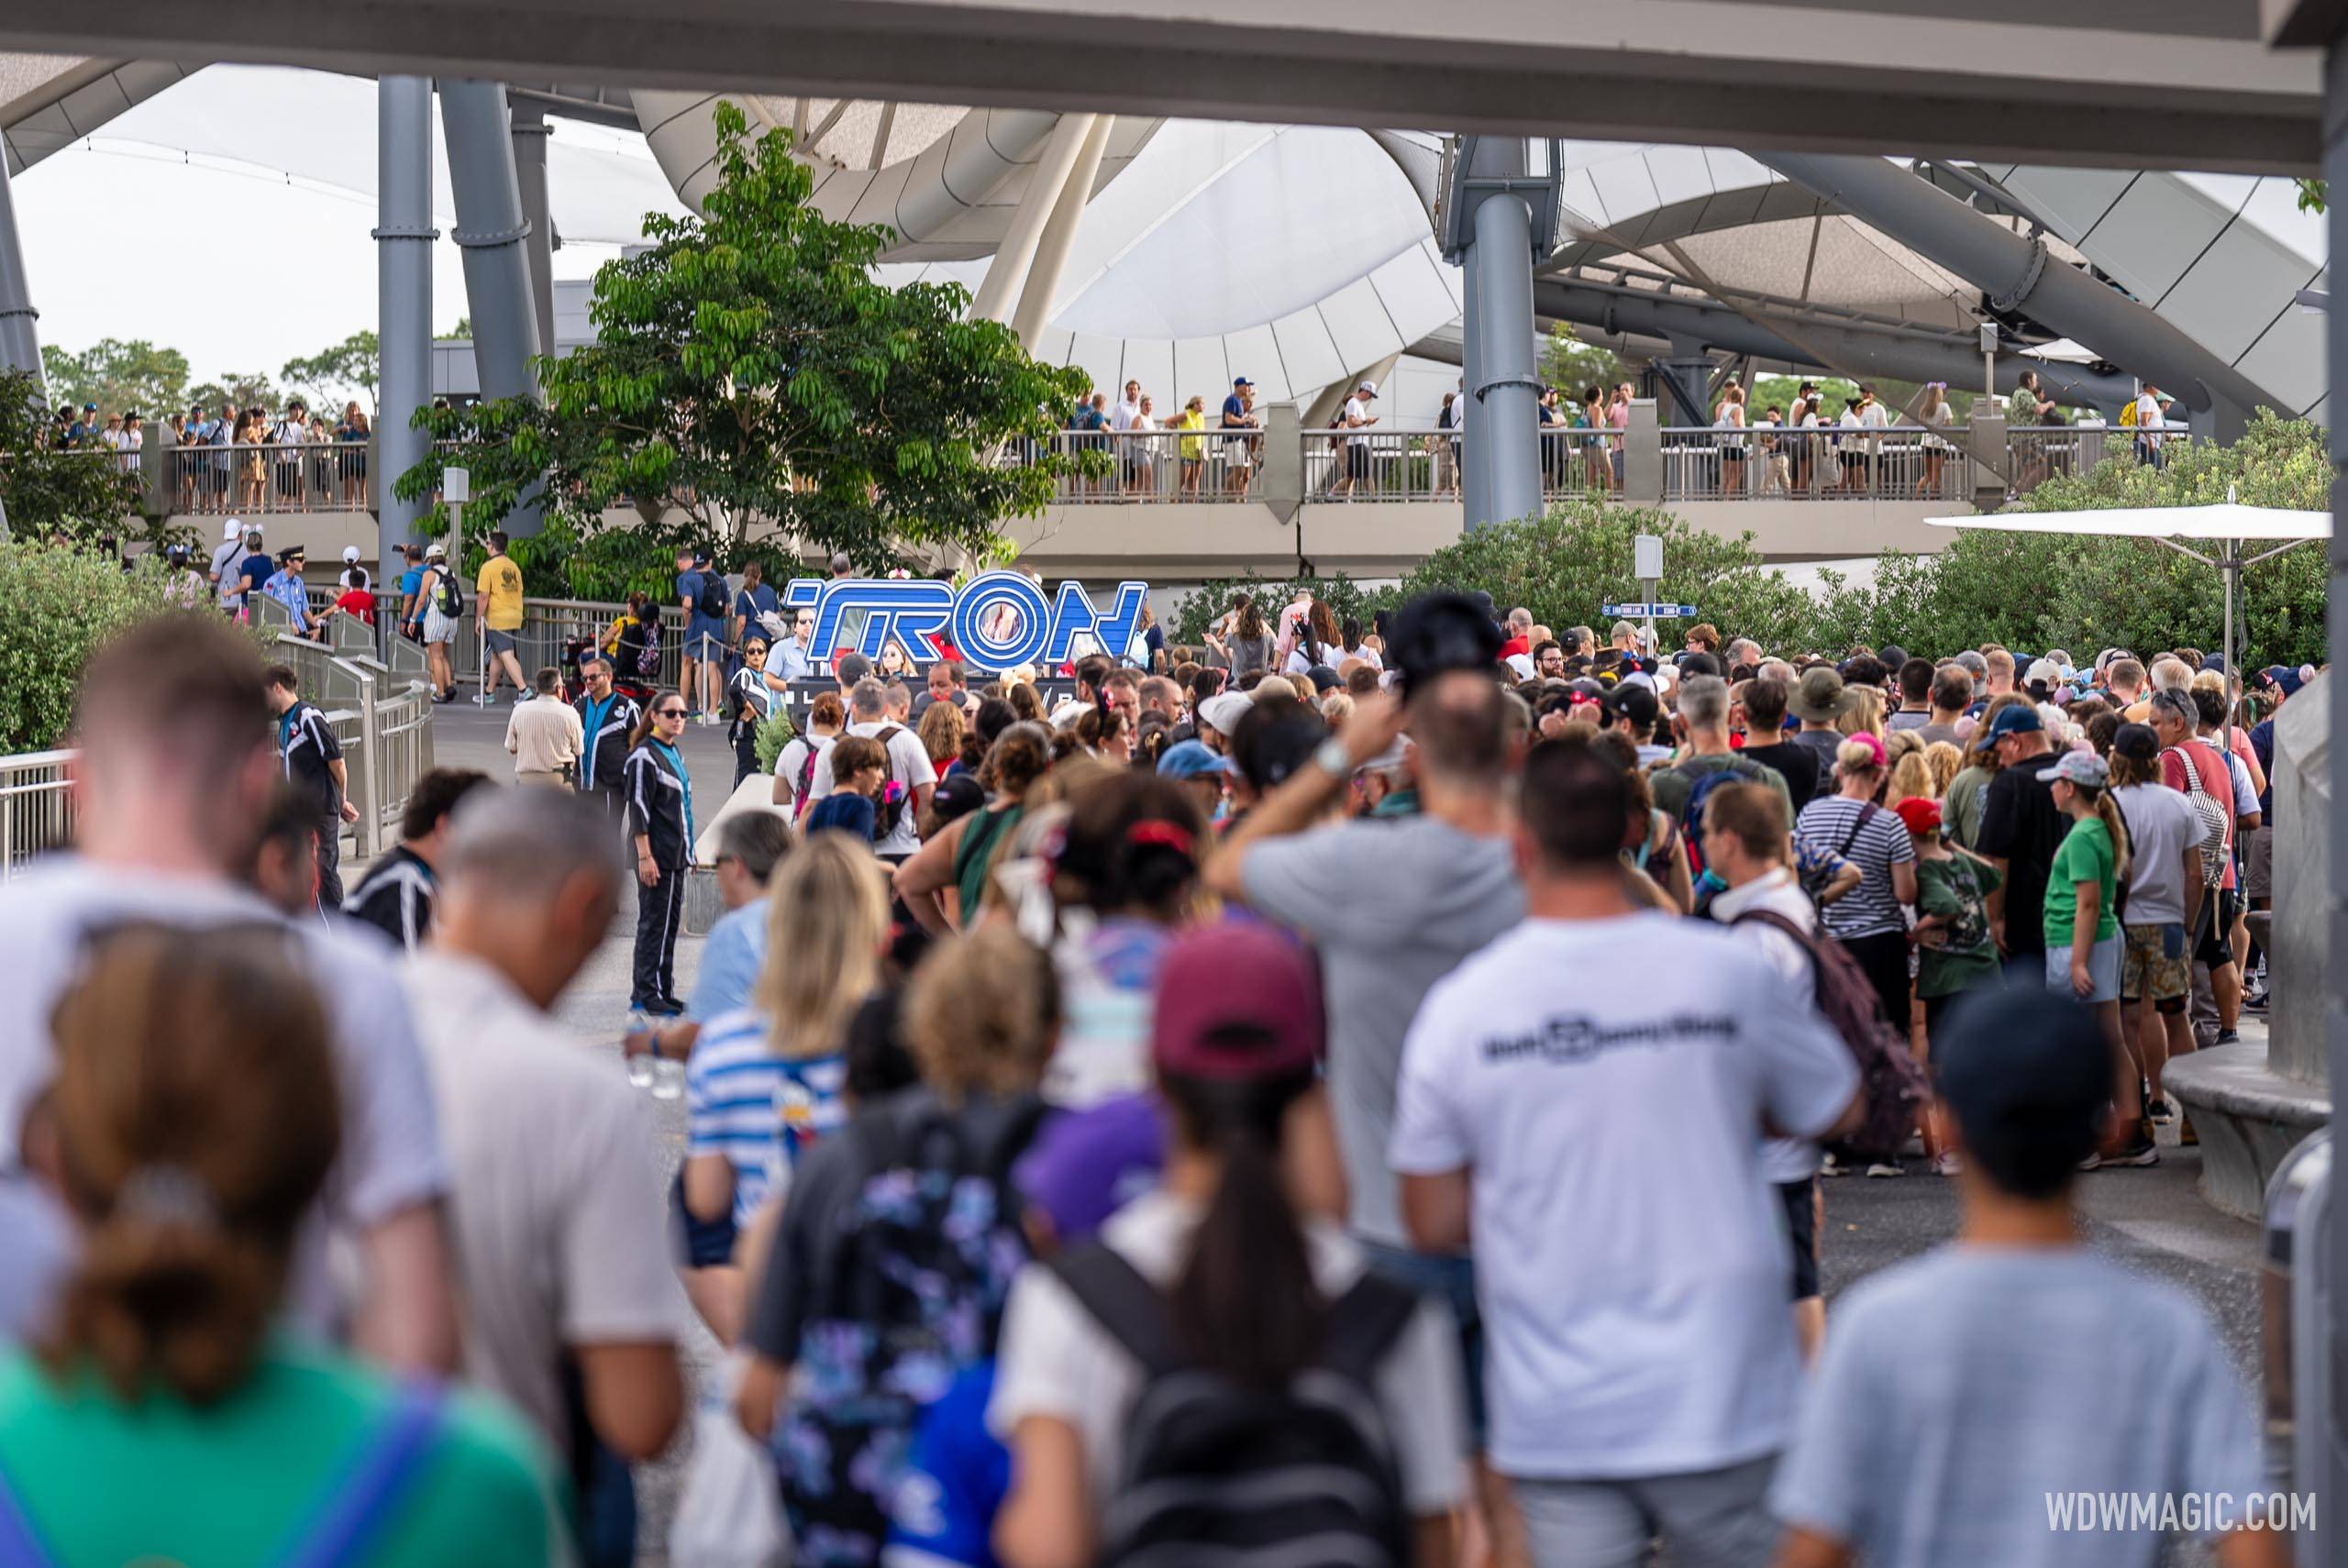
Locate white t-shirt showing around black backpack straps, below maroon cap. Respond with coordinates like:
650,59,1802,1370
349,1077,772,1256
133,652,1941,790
986,1190,1456,1517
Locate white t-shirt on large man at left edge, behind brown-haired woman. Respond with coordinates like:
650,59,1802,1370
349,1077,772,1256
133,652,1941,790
0,855,449,1329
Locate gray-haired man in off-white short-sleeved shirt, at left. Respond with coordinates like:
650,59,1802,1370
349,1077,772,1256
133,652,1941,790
406,789,686,1561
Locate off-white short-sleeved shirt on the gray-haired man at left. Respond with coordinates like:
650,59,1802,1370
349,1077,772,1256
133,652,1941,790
404,951,686,1453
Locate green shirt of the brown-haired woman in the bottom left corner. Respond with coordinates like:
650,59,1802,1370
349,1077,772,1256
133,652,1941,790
0,1341,569,1568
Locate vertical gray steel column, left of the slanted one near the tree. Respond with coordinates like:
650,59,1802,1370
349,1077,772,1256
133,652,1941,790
371,75,439,570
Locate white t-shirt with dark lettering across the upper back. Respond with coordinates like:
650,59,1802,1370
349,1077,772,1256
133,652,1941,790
1388,913,1860,1479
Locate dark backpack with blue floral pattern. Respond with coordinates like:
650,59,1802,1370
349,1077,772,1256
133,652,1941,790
772,1089,1045,1561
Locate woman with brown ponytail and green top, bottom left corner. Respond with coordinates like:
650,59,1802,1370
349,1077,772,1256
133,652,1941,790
0,925,559,1568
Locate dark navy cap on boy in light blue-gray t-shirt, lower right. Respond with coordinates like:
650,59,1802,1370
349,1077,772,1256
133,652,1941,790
1933,986,2110,1198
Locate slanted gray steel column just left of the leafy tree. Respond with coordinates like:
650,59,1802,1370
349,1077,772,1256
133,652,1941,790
439,83,540,536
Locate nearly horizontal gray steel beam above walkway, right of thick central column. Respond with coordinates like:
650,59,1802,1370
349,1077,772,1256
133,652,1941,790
1534,280,2134,408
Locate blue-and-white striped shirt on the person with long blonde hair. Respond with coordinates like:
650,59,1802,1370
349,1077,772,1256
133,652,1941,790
686,1007,847,1225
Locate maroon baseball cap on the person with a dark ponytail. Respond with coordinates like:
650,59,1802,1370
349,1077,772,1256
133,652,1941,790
1150,920,1324,1082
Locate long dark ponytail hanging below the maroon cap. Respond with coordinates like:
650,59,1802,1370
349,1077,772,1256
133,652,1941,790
1160,1073,1329,1389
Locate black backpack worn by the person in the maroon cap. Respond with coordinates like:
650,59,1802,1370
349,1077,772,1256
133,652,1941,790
1049,1246,1418,1568
